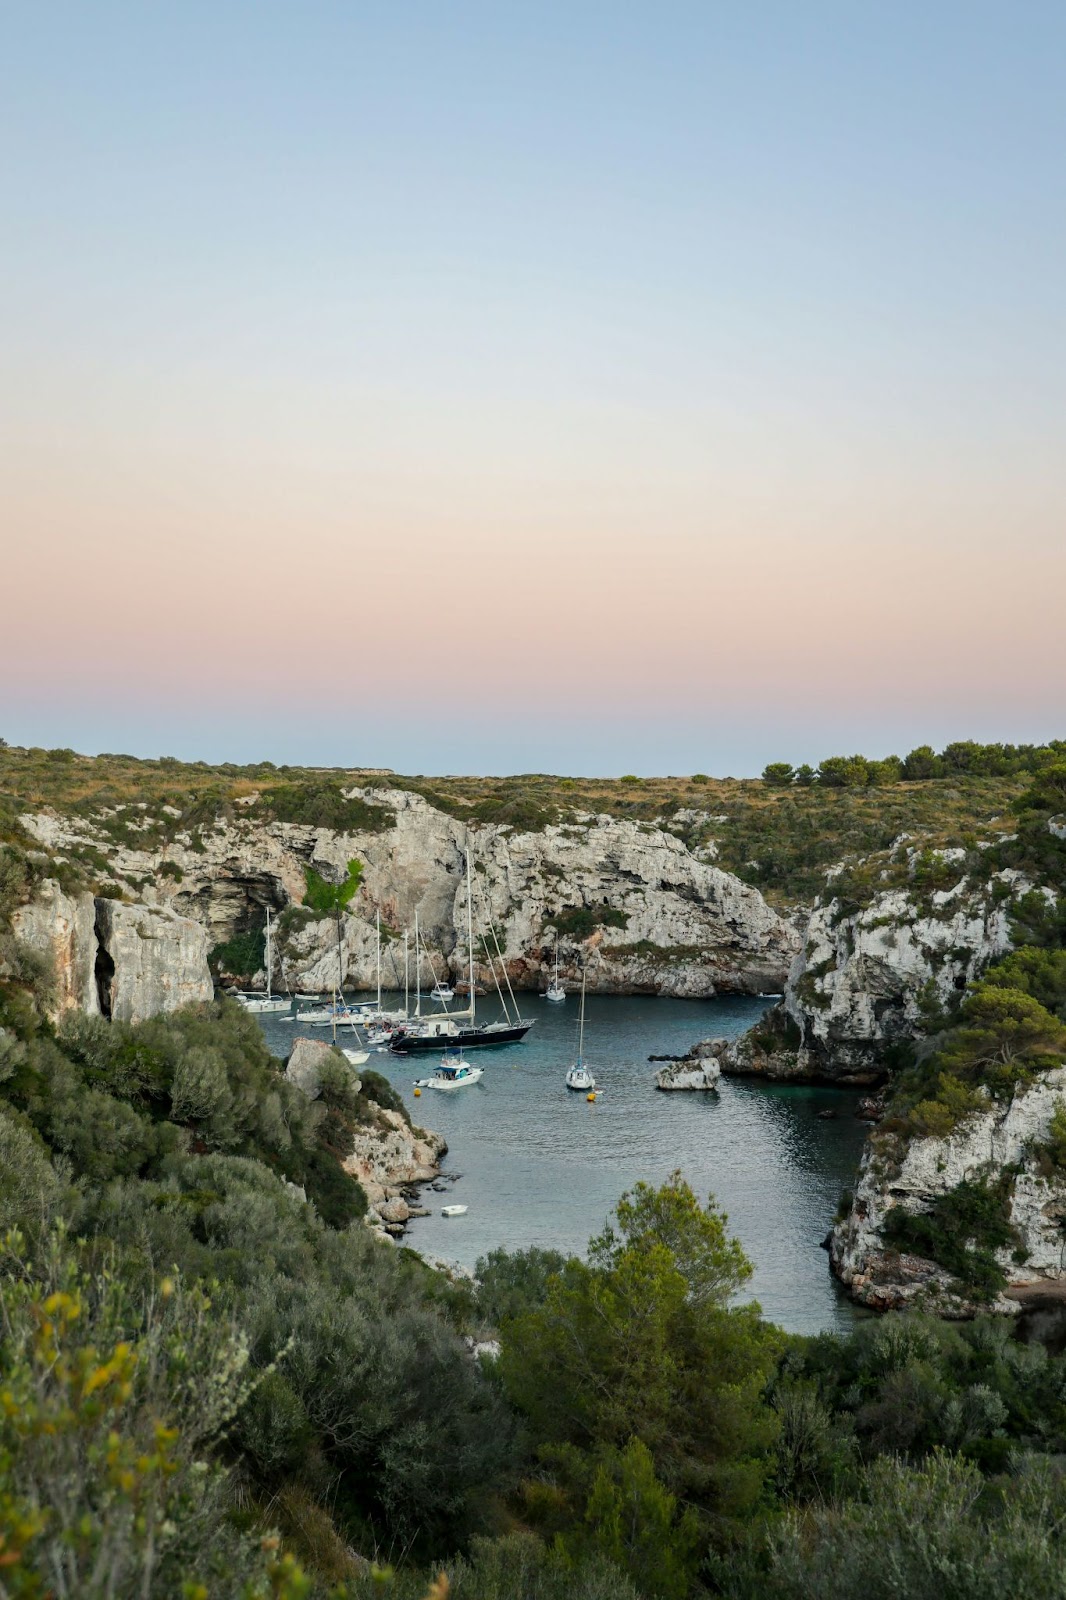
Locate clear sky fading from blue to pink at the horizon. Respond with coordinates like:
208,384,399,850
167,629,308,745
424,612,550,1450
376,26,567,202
0,0,1066,776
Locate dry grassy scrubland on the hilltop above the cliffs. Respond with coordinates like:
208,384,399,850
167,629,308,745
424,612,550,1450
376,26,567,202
0,747,1026,907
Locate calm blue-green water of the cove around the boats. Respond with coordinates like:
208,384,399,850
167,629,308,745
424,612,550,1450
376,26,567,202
259,995,864,1333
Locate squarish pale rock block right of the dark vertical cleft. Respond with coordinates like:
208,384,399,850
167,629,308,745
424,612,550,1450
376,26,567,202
96,899,214,1022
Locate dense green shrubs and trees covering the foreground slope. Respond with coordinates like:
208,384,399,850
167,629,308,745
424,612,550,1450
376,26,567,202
0,952,1066,1600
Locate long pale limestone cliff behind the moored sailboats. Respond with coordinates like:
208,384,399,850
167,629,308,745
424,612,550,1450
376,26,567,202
22,789,799,997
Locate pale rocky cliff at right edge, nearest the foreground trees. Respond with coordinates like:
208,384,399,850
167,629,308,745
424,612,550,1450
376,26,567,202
829,1067,1066,1317
